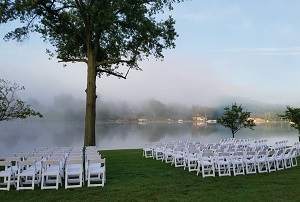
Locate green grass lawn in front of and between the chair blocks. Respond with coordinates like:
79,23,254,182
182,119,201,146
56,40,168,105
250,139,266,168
0,150,300,202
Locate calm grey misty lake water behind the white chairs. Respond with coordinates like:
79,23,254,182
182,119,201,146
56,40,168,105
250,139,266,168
0,121,298,158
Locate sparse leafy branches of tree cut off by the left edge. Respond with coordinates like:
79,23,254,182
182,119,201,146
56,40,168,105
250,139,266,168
0,79,43,121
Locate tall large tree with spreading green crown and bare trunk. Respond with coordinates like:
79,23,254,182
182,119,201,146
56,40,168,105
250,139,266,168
0,0,183,146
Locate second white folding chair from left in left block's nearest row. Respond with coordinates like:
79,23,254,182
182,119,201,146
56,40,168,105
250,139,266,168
17,160,39,190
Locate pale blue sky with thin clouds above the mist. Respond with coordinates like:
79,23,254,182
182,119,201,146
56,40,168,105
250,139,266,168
0,0,300,107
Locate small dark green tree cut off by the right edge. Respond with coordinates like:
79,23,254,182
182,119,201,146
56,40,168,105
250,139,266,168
278,106,300,142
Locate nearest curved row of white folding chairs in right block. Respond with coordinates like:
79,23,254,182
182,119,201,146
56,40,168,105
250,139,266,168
192,148,290,177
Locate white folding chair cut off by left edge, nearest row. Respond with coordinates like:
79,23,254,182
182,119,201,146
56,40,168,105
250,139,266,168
0,161,16,191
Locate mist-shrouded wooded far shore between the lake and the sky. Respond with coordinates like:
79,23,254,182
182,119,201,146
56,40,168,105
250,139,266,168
23,94,298,122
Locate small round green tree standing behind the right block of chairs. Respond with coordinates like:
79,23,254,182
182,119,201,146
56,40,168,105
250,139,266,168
217,103,255,138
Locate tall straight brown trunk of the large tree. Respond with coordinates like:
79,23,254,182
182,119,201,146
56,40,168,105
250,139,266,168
84,52,97,146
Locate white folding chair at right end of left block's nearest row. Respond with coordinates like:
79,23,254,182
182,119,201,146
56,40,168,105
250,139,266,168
87,158,106,187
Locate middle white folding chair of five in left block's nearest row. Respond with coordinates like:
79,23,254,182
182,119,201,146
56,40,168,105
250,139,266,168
41,160,62,189
